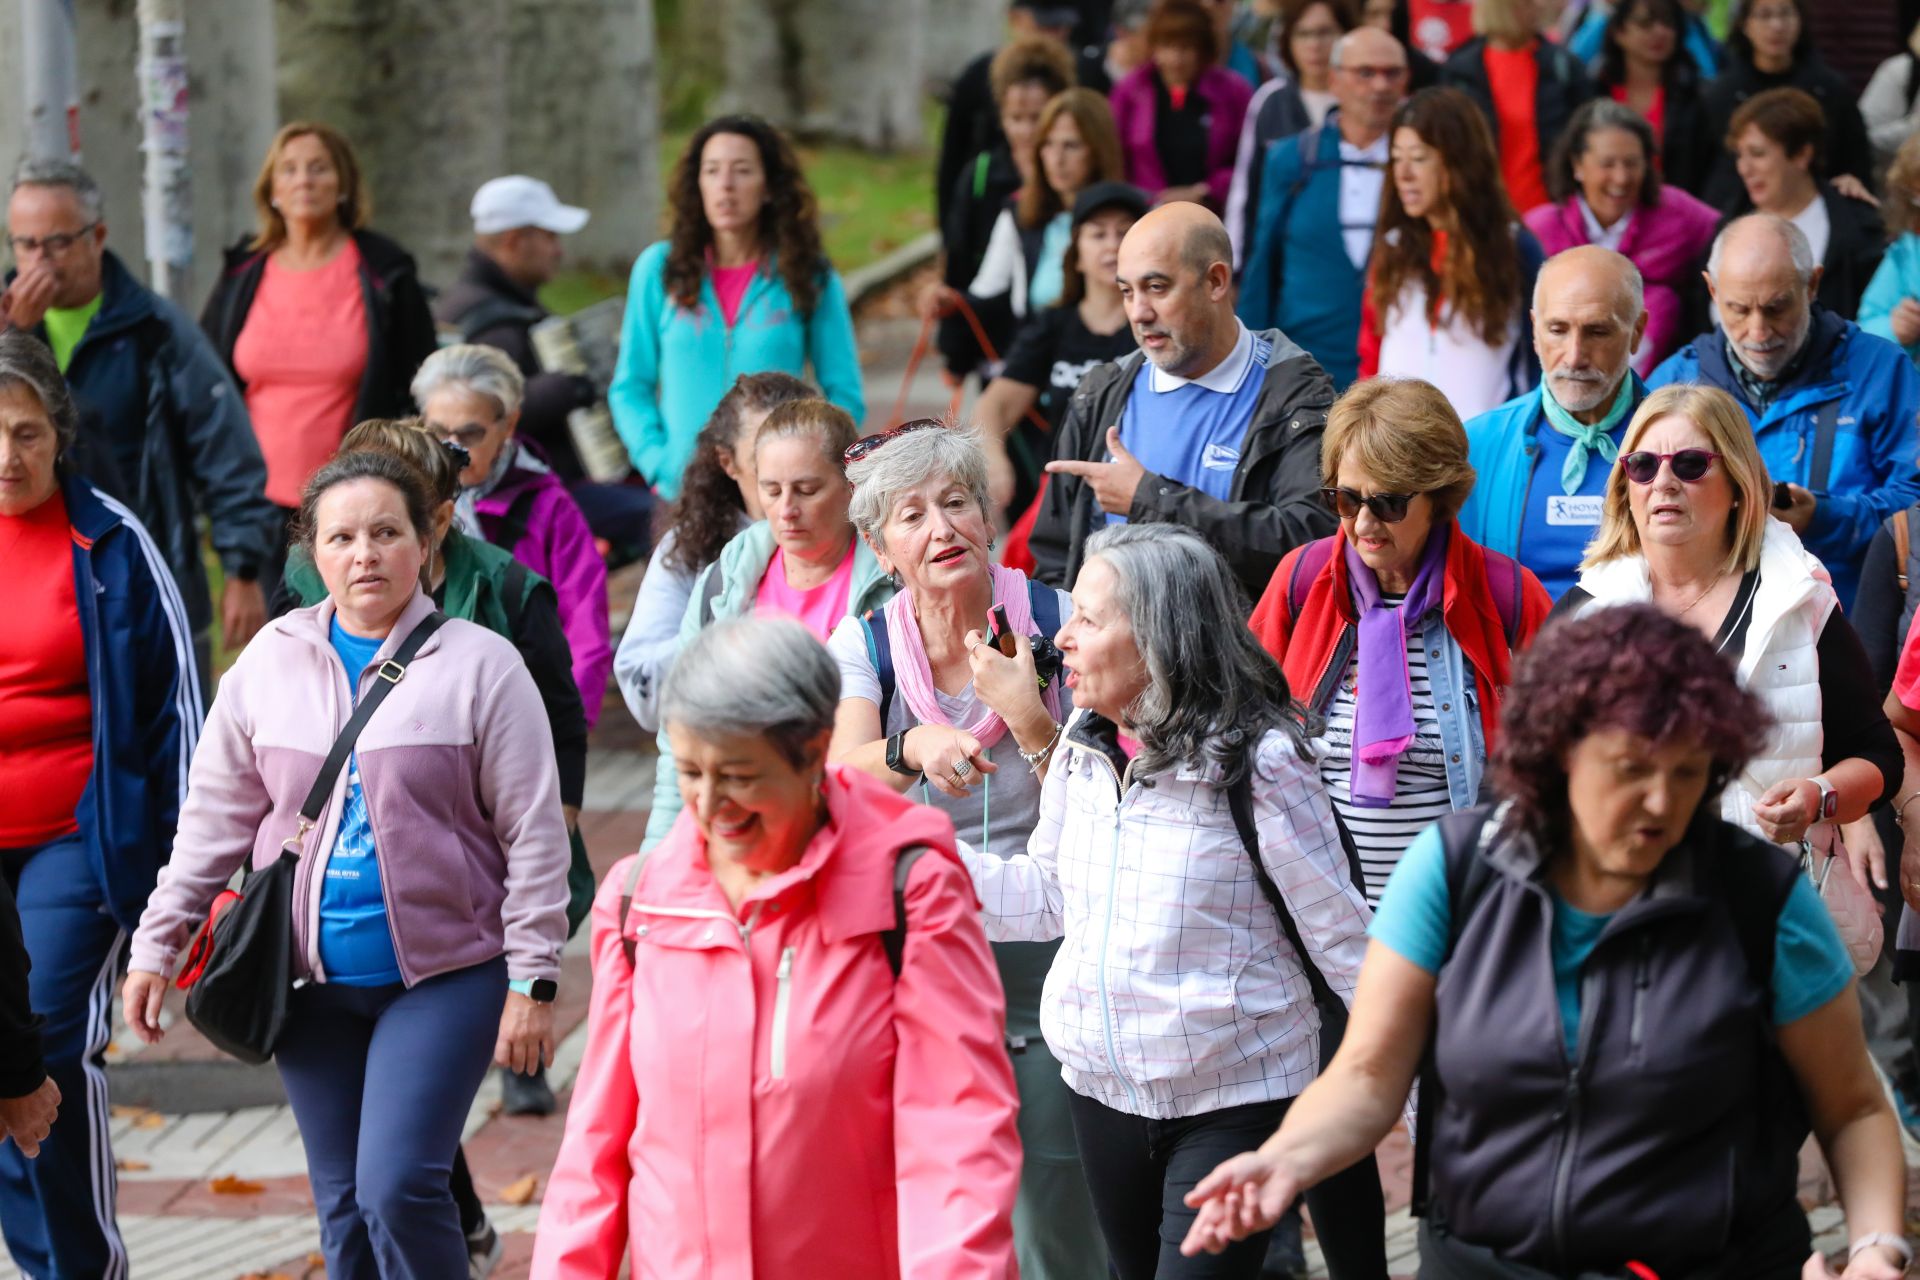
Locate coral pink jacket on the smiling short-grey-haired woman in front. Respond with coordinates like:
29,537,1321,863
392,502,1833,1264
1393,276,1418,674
532,768,1020,1280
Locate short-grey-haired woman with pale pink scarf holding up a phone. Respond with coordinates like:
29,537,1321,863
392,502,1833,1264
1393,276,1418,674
828,420,1108,1280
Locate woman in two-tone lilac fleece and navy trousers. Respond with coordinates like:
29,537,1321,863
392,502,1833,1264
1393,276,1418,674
123,453,568,1280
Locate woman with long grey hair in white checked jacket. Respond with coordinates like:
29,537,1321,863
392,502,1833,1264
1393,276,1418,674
962,524,1386,1280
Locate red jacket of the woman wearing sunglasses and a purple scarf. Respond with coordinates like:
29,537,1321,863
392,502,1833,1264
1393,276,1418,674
1252,522,1553,750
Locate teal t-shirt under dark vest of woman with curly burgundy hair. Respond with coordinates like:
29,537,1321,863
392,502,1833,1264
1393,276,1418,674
1367,827,1853,1061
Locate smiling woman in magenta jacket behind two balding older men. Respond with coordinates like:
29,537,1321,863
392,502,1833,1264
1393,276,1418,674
1526,98,1720,378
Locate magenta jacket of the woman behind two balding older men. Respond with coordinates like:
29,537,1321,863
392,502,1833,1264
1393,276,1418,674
1526,182,1720,378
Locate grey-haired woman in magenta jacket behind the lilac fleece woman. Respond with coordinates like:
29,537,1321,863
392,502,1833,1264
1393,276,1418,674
413,344,612,729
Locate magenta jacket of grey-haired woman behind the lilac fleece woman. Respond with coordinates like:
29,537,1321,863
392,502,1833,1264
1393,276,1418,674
474,455,612,729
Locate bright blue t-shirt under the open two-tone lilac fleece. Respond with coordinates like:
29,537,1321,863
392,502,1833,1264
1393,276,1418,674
321,616,399,986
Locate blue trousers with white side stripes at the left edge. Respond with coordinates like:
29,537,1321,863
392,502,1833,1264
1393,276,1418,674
0,835,127,1280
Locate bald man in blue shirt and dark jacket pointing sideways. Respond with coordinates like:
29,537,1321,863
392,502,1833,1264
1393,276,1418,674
1031,201,1334,599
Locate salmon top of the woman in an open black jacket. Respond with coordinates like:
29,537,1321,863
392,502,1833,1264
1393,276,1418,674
234,240,367,507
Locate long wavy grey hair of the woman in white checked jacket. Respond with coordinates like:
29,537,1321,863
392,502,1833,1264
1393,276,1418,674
1087,524,1308,783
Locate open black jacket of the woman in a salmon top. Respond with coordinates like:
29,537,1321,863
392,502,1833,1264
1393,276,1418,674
200,230,440,443
